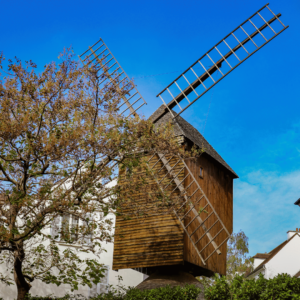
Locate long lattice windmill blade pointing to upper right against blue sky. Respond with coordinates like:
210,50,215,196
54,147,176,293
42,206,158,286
157,4,289,118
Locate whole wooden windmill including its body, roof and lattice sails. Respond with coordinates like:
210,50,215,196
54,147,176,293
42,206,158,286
80,4,288,282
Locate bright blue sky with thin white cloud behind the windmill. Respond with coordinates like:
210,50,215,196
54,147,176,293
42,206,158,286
0,0,300,255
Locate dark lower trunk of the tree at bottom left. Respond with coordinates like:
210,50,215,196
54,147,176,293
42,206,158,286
14,245,31,300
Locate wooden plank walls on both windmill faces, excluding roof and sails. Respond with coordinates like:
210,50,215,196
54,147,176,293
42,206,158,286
113,153,233,275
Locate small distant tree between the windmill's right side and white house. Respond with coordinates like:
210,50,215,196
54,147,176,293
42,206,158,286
226,230,253,281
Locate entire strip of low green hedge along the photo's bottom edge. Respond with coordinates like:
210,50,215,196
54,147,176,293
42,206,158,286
24,274,300,300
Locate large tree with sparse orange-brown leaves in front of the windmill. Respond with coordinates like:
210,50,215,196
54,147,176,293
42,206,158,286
0,50,185,300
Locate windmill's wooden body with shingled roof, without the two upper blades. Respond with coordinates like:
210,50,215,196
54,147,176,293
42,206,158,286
113,105,238,281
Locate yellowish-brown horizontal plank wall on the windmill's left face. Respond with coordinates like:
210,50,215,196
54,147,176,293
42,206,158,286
113,157,184,270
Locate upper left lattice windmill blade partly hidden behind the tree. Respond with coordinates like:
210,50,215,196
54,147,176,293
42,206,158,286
79,38,147,117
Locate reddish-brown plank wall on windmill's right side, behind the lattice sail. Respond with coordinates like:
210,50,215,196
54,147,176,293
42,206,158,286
184,154,233,275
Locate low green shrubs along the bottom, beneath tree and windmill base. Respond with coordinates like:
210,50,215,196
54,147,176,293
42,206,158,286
27,285,201,300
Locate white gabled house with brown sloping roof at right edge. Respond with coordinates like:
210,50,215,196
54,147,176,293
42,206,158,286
247,231,300,279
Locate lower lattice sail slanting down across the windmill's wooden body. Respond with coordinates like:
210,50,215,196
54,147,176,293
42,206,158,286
148,153,231,265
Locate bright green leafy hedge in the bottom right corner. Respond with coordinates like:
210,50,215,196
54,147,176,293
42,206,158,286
205,274,300,300
